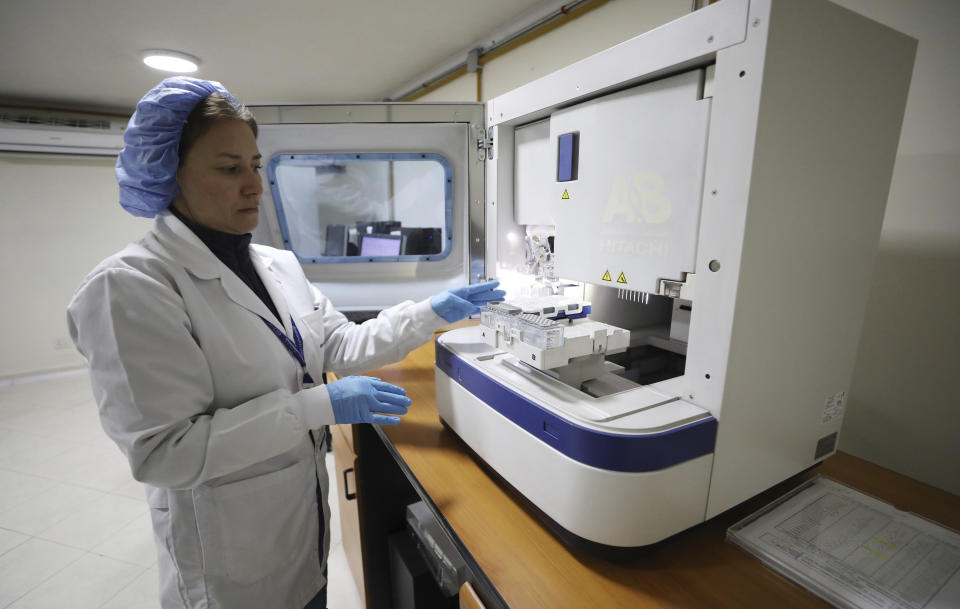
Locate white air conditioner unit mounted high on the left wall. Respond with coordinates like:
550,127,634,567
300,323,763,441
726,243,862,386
0,108,127,156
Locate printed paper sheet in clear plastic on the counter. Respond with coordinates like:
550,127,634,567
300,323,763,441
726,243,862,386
727,476,960,609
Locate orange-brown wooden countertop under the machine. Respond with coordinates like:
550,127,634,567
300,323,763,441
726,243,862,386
370,334,960,609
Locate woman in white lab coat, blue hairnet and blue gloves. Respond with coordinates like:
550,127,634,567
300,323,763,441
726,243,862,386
68,77,503,609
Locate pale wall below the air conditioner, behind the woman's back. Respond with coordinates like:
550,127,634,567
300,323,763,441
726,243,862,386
0,154,150,378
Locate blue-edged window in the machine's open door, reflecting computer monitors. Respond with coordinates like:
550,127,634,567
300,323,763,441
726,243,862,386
267,153,453,263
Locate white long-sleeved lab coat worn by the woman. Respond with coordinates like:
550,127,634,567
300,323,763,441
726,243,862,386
67,212,446,609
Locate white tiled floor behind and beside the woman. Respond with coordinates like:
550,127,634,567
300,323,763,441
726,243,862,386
0,373,361,609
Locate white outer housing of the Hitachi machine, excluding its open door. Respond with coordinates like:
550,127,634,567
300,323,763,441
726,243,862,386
436,0,916,548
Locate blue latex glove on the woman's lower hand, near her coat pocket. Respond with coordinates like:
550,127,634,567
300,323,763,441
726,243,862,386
327,376,410,425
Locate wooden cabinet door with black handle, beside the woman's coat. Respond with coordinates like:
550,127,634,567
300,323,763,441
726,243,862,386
331,425,366,606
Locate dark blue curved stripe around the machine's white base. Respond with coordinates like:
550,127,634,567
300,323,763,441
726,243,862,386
434,341,717,472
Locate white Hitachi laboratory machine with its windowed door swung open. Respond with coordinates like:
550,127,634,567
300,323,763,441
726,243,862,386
253,0,916,555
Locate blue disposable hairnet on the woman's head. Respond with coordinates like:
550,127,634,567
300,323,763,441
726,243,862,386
116,76,236,218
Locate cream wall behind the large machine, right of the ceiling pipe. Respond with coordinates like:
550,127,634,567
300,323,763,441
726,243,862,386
424,0,960,493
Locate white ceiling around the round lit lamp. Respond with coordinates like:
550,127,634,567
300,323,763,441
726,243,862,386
0,0,559,114
